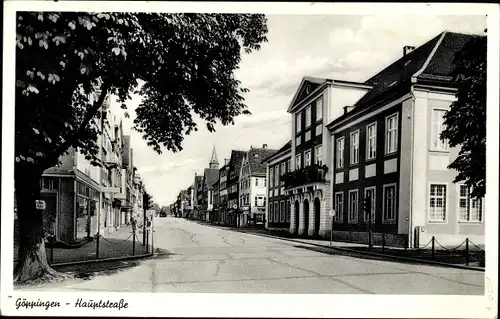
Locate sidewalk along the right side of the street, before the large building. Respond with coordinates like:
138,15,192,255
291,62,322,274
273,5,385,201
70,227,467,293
205,223,485,271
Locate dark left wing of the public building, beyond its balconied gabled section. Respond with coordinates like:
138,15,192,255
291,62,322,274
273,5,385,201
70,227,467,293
264,140,292,230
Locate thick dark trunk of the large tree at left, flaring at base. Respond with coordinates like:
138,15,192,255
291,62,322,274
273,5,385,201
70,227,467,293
14,162,67,283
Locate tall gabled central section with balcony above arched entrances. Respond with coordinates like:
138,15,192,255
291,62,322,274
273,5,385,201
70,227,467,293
282,77,371,236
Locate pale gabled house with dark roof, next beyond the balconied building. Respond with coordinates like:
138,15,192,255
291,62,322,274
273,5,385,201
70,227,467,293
236,144,276,227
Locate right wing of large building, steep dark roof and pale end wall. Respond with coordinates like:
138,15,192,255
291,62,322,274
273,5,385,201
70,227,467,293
328,32,484,247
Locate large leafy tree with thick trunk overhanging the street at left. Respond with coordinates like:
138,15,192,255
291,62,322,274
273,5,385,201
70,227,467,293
14,12,267,282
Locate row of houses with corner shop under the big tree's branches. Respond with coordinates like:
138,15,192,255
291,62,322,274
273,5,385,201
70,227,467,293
33,93,145,243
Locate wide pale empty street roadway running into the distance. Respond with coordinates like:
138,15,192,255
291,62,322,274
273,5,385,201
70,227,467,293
17,217,485,295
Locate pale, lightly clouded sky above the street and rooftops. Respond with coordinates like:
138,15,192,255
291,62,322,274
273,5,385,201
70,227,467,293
108,15,486,206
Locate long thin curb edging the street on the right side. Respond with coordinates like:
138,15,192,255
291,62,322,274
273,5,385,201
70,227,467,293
202,225,485,272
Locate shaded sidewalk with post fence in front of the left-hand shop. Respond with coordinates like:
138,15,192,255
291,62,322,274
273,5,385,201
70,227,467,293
14,226,151,265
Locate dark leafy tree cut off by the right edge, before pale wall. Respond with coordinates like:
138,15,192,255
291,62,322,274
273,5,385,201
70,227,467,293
441,36,486,198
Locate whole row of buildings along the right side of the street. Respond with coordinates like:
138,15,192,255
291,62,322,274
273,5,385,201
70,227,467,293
172,32,485,247
